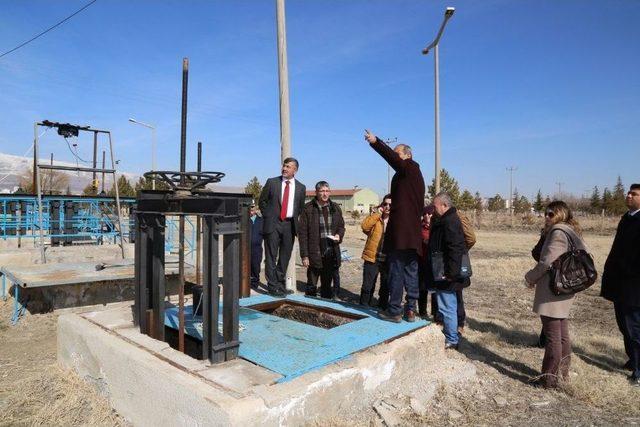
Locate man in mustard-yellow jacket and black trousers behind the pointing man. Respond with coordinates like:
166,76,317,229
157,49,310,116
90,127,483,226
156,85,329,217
360,194,391,310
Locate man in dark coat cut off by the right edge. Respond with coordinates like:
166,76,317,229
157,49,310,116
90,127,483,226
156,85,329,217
602,184,640,387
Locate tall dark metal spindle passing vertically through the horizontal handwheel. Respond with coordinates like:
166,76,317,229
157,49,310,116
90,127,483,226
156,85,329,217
178,58,189,353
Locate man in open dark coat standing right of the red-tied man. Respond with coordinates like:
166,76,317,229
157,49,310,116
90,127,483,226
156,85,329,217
298,181,344,299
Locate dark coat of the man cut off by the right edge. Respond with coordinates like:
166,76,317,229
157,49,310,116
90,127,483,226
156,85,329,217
602,212,640,307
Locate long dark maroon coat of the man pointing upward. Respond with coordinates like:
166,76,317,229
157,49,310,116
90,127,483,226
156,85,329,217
371,138,424,254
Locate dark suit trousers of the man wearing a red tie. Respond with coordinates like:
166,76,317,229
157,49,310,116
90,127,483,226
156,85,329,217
264,220,295,292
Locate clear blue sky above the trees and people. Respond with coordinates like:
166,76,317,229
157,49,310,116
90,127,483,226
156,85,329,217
0,0,640,196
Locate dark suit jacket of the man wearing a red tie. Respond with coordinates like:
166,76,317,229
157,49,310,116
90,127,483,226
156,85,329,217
258,176,307,235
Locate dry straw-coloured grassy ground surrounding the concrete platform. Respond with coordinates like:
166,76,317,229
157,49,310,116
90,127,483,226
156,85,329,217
0,226,640,426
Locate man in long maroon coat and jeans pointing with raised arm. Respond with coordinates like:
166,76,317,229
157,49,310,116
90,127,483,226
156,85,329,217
365,131,424,322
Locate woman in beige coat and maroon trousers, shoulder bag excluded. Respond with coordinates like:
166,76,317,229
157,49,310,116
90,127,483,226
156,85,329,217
525,201,586,388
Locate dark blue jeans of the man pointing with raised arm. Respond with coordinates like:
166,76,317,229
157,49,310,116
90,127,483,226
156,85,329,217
387,249,418,316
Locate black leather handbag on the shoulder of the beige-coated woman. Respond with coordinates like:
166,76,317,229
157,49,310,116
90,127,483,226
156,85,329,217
549,228,598,295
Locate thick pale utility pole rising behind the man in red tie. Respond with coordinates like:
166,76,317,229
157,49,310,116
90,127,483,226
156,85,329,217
276,0,298,292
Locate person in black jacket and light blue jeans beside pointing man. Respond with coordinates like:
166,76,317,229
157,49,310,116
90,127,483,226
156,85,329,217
426,193,471,349
